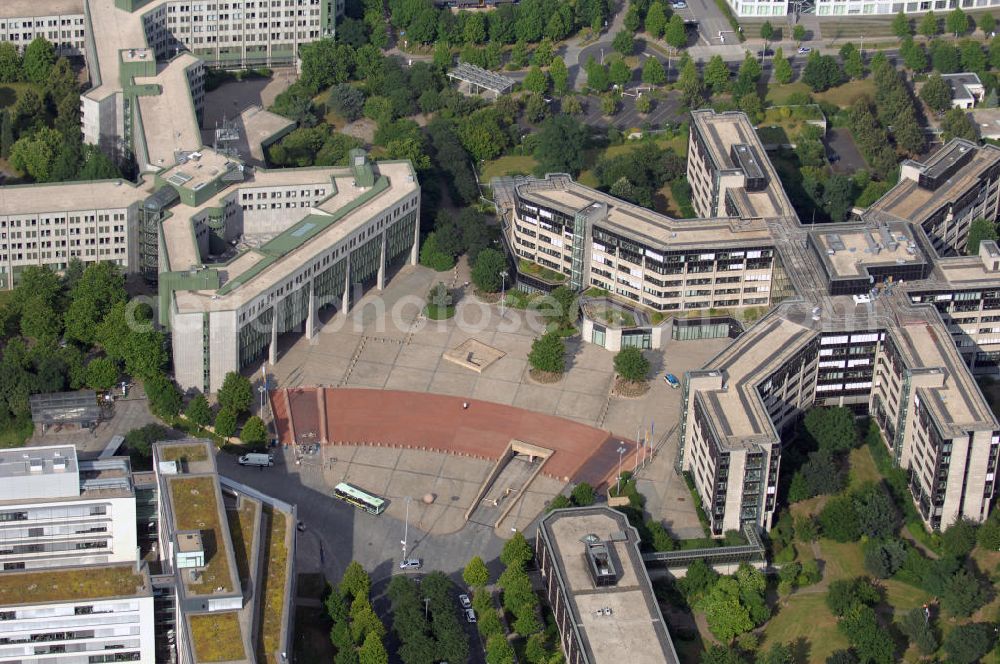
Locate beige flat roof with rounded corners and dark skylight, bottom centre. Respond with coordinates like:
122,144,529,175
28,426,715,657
539,506,679,664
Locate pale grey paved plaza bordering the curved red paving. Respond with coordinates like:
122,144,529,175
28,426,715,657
258,266,730,537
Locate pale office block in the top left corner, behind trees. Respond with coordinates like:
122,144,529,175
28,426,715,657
0,0,86,56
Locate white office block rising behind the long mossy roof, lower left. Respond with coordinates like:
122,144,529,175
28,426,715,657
0,445,136,572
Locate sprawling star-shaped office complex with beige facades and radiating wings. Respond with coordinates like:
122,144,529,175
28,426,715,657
494,111,1000,535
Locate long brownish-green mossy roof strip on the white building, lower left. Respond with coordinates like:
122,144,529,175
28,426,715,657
0,565,152,606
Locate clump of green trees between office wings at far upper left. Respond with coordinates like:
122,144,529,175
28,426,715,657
0,37,121,182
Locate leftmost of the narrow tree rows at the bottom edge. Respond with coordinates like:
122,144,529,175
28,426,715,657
325,561,389,664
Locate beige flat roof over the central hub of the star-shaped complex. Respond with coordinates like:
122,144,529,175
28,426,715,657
812,224,926,278
